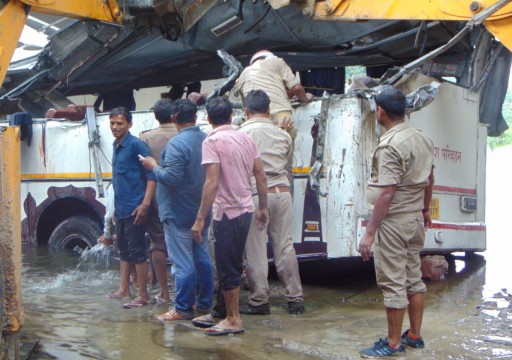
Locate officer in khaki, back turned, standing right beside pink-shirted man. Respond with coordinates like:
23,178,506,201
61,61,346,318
238,90,304,315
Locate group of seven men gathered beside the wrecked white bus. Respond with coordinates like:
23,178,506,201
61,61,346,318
101,51,433,357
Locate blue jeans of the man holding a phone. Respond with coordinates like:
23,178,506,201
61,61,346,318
164,220,213,316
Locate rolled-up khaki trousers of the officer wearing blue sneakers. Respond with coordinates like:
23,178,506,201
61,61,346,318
373,211,427,309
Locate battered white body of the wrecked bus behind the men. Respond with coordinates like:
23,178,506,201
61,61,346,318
5,71,496,259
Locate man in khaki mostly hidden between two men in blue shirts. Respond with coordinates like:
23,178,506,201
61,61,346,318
139,99,178,303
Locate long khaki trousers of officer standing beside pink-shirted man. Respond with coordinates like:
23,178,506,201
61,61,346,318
245,190,303,306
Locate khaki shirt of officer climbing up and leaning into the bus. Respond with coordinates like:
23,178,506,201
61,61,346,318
237,57,299,114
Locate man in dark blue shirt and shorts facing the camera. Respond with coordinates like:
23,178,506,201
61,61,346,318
109,108,156,309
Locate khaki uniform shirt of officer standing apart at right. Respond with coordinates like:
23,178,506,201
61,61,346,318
366,122,434,215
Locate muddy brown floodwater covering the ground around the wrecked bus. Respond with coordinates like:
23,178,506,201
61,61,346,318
21,145,512,360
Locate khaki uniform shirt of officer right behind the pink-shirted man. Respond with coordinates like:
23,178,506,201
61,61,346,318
238,117,293,194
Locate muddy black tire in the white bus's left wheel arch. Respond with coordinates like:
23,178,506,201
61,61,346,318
48,216,102,250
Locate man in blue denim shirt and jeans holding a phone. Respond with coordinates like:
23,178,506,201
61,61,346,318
141,100,213,321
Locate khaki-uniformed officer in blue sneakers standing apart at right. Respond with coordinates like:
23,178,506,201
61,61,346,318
359,88,434,357
